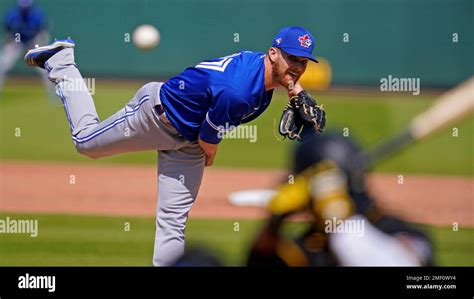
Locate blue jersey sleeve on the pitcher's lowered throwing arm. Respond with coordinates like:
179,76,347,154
199,85,251,144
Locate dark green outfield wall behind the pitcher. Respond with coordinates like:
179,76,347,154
0,0,474,87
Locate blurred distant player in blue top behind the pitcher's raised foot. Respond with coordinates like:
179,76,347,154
0,0,56,101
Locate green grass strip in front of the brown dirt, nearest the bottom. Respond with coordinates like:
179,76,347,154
0,213,474,266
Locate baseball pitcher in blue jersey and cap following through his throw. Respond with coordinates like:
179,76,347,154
25,27,325,266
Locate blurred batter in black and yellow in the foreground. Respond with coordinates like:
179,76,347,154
248,134,432,266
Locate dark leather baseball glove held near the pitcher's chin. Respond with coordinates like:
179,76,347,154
278,90,326,141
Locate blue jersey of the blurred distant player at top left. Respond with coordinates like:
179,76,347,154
5,8,46,43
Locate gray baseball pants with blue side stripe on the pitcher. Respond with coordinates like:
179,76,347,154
45,48,205,266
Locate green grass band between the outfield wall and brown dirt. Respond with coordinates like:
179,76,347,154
0,79,474,176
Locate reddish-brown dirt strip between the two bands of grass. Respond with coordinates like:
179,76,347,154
0,162,474,226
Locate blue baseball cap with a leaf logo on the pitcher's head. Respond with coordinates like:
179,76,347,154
272,26,318,62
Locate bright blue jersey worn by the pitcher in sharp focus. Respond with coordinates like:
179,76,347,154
160,51,273,144
